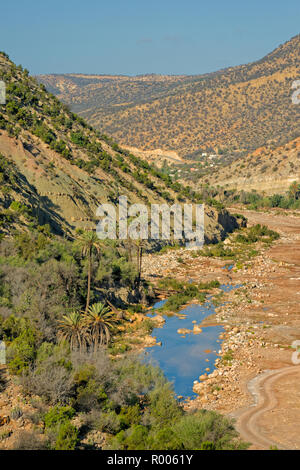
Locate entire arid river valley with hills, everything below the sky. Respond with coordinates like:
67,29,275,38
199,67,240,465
0,28,300,451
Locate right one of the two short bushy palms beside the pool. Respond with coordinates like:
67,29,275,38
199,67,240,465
84,302,118,350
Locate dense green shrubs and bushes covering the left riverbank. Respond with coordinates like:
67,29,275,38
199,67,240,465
0,231,251,450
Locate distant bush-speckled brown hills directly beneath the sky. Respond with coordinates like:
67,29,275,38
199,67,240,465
38,35,300,156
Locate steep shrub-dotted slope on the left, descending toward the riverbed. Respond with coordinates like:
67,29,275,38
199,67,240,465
0,53,236,240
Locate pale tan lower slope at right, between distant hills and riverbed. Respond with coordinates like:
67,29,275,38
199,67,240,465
183,137,300,195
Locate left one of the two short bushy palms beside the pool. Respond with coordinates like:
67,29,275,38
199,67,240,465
58,311,87,352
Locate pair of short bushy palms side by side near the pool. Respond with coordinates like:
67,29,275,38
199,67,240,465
58,302,118,352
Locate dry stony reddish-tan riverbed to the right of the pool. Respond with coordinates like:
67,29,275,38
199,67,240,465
144,211,300,446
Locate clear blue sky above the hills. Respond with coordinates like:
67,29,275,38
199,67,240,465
0,0,300,75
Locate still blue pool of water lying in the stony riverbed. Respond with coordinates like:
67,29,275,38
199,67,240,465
147,285,239,398
